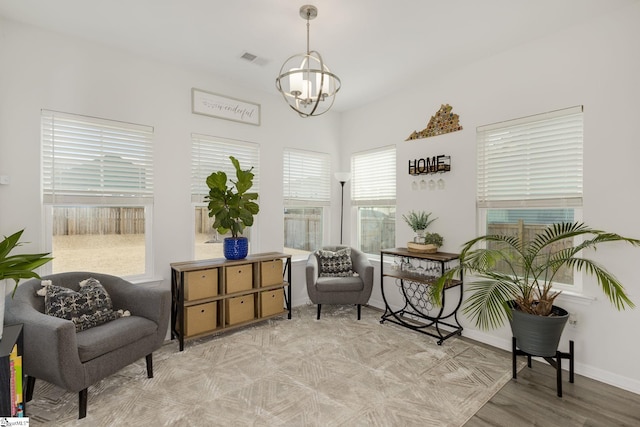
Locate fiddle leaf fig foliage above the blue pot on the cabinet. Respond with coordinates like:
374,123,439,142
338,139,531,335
206,156,260,238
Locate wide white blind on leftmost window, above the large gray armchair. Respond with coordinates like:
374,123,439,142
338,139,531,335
41,110,153,205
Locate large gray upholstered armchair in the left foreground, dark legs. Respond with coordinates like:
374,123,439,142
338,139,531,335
5,272,171,418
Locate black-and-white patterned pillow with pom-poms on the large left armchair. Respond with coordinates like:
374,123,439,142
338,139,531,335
37,278,129,332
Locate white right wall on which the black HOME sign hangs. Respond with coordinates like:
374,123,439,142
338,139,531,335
341,4,640,393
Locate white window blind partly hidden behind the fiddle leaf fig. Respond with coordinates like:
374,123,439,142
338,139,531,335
191,133,260,203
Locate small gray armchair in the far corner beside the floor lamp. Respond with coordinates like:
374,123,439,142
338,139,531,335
306,246,373,320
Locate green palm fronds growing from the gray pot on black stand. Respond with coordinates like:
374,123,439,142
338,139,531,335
432,222,640,329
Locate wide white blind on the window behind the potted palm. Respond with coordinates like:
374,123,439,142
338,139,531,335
476,106,583,208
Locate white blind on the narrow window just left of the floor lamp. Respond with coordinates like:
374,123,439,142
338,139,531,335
282,148,331,206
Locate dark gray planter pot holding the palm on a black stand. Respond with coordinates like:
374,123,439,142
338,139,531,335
510,304,569,357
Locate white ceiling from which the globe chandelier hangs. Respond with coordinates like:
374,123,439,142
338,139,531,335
0,0,640,111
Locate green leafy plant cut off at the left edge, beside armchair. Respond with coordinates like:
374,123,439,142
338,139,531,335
0,230,53,297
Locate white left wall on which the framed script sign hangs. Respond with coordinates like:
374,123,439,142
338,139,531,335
0,19,340,310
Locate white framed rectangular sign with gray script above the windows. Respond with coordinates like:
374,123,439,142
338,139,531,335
191,88,260,126
